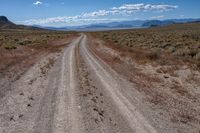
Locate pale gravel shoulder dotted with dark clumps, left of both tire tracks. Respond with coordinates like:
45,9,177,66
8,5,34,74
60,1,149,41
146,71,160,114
0,51,59,133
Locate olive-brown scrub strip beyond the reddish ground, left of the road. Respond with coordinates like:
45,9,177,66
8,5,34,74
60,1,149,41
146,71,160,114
0,30,75,50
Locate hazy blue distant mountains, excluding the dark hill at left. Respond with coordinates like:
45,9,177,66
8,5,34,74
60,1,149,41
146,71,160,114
36,18,200,31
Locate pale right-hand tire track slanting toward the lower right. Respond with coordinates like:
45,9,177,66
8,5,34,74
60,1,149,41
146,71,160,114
80,36,157,133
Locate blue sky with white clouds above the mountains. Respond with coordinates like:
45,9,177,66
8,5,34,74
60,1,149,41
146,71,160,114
0,0,200,27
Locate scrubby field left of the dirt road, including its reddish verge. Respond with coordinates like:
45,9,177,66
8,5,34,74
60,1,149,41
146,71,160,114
0,29,77,96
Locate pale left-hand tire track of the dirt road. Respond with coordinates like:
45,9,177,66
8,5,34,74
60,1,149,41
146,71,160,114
53,36,82,133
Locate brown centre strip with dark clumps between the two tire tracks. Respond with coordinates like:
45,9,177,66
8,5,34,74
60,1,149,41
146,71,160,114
75,43,131,133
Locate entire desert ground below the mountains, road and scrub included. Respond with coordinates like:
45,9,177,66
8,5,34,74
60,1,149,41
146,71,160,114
0,24,200,133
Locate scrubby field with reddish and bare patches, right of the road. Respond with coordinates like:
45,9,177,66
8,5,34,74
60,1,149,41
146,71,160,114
88,23,200,133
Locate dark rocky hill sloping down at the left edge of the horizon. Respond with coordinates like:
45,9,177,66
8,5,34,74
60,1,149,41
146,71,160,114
0,16,40,29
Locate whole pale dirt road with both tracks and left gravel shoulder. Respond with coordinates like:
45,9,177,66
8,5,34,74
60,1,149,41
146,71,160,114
0,34,198,133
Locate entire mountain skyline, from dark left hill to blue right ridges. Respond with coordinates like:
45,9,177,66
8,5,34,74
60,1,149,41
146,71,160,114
0,16,200,31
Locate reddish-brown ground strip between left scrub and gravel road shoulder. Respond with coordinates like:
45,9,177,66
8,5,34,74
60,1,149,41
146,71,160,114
0,35,76,97
